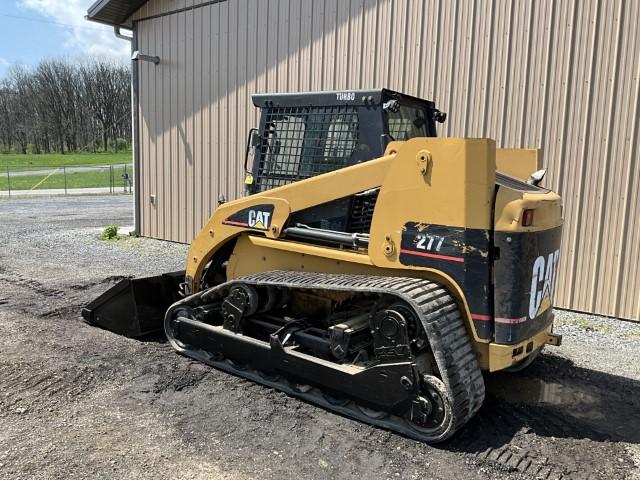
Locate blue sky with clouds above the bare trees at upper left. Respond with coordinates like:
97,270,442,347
0,0,131,79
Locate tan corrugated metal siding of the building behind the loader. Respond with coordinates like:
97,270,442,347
135,0,640,319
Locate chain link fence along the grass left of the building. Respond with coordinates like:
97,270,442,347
0,163,134,196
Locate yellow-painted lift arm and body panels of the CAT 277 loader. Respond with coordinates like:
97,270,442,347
186,138,562,370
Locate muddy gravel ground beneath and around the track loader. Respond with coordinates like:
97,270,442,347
0,196,640,480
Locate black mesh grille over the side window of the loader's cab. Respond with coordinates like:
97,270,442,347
255,105,358,191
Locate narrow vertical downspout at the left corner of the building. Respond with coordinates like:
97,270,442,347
113,23,140,236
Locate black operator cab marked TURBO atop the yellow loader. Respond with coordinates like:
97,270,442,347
245,89,446,194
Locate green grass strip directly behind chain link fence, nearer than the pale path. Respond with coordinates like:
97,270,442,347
0,165,133,190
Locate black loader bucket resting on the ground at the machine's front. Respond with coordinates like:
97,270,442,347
82,271,184,337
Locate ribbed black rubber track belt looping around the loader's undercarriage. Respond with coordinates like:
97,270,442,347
165,271,485,443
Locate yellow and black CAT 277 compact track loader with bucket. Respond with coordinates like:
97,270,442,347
83,89,562,442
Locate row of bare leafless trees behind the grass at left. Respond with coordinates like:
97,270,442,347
0,60,131,154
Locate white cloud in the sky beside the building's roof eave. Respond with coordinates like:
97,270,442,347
18,0,131,61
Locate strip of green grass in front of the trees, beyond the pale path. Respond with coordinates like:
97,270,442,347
0,152,132,172
